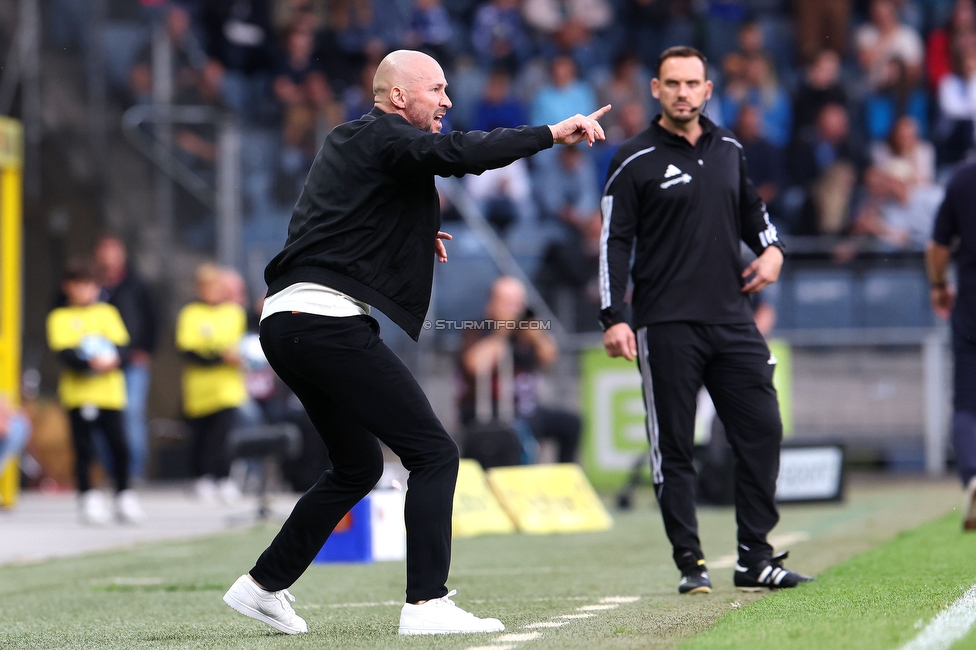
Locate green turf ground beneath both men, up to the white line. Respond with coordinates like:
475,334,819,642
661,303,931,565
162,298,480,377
0,484,976,650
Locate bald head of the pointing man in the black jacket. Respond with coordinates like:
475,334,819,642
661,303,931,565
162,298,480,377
373,50,451,133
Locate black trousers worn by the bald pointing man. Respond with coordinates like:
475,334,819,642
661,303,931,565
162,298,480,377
251,313,458,602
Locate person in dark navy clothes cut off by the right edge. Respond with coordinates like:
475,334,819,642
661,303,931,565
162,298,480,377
925,162,976,530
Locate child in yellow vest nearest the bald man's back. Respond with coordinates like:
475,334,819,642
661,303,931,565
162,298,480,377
176,264,247,502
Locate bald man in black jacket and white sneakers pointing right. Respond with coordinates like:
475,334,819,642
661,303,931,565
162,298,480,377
224,51,610,634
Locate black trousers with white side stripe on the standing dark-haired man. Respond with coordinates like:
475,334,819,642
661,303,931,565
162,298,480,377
636,323,783,571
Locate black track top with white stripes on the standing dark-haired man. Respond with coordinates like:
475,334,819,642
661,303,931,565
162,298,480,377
600,117,783,329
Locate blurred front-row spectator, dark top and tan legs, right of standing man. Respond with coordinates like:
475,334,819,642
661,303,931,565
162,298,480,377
787,104,867,235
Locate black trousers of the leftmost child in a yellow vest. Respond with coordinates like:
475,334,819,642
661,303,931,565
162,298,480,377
68,407,129,492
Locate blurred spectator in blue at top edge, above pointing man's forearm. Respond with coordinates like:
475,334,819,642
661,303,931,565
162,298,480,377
471,0,532,74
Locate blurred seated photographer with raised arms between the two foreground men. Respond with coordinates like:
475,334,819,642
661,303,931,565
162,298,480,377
458,276,581,463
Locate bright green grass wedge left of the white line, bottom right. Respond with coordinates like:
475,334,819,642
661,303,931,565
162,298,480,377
679,514,976,650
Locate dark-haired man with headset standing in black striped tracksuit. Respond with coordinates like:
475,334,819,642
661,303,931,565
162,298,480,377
600,47,812,593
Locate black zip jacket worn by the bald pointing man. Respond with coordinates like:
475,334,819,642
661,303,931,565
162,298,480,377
264,108,552,340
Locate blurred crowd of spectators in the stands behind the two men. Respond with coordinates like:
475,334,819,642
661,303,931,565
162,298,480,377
50,0,976,326
